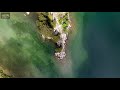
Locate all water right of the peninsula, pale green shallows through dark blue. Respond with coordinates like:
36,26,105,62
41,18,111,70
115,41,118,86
71,12,120,77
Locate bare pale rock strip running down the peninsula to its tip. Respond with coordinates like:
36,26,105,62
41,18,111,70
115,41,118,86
51,12,71,60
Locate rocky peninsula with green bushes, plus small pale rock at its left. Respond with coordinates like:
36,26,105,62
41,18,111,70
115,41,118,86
25,12,71,60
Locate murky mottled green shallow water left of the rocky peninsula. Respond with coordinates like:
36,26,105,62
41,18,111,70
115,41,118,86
0,12,60,77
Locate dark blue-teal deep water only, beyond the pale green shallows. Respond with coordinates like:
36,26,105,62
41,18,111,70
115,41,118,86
79,12,120,77
